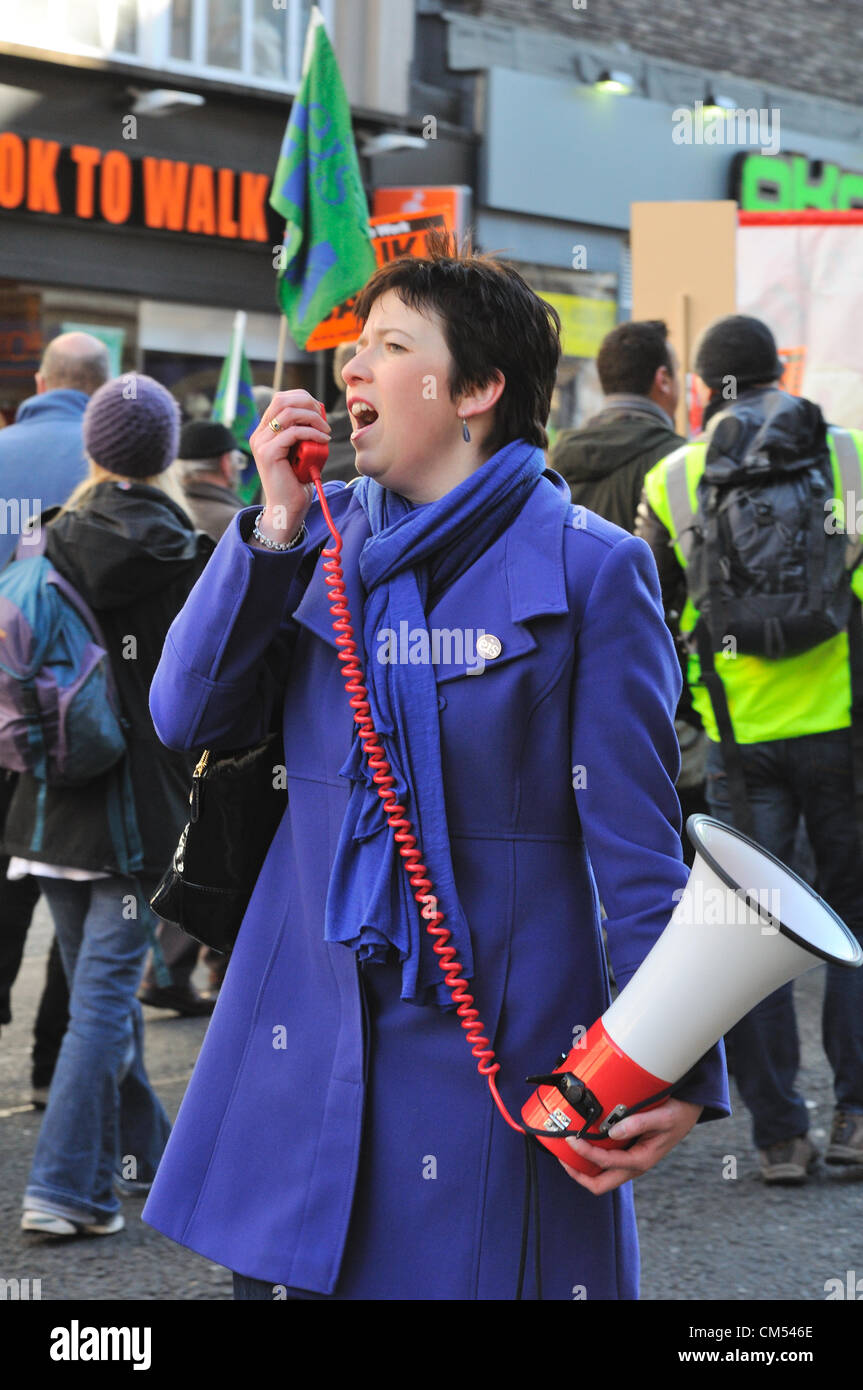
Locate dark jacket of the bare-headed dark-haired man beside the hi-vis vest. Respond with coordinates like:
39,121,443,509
549,406,685,531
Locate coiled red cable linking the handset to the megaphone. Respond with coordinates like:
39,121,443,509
309,467,527,1134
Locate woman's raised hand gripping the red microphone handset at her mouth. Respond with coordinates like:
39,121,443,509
249,391,331,545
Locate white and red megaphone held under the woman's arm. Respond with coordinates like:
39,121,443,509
521,816,863,1175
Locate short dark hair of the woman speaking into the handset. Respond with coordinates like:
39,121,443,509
354,231,560,453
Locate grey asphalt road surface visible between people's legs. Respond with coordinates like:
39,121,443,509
0,902,863,1315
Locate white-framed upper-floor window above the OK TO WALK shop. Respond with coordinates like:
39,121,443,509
4,0,334,90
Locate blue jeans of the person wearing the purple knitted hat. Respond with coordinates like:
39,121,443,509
24,877,171,1222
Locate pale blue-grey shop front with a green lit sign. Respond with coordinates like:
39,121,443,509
466,62,863,430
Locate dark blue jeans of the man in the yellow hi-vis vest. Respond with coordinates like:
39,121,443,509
707,728,863,1148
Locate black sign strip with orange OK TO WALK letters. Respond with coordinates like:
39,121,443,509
0,131,274,243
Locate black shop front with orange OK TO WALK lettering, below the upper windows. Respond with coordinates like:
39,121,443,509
0,58,314,423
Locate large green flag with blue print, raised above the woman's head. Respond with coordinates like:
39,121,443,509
270,6,375,348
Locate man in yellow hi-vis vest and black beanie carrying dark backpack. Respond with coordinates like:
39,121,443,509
635,314,863,1183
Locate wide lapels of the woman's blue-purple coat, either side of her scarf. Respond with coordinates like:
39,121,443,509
293,468,571,684
